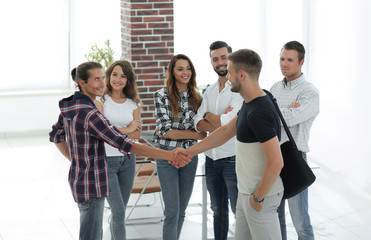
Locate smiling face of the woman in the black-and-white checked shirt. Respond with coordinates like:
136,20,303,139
173,59,192,91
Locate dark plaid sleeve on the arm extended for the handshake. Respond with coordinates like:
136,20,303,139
88,110,134,153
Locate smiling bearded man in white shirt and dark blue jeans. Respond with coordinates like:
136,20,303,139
194,41,243,240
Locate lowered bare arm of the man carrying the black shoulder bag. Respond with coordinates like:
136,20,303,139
250,136,283,211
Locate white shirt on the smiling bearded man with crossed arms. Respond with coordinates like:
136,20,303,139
194,80,243,160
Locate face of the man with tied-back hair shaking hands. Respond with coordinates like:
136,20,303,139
79,68,104,100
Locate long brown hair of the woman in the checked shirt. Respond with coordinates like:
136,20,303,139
165,54,202,119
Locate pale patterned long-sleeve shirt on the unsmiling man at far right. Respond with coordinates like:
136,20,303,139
271,74,319,152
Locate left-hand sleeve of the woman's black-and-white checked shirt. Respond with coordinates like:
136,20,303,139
154,92,172,136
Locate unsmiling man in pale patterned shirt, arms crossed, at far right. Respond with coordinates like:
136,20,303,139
271,41,319,240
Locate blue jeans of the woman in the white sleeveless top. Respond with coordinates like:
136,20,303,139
107,154,135,240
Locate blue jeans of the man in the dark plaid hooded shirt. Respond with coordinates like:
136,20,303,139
77,197,105,240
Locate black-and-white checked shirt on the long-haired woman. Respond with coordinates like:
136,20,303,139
154,88,197,148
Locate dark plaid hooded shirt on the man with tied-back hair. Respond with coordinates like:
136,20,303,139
49,92,134,203
